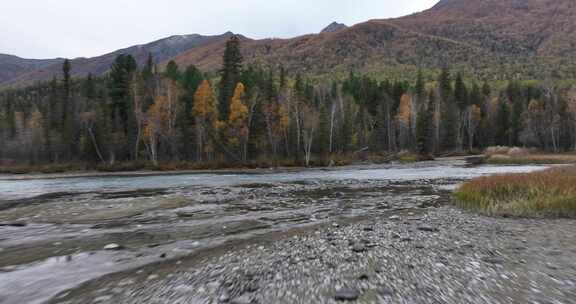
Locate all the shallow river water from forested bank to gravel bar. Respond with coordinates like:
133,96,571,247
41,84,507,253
0,160,544,304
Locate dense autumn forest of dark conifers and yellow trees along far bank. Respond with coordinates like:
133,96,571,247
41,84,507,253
0,37,576,168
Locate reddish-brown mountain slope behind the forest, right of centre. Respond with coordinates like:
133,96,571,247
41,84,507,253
170,0,576,77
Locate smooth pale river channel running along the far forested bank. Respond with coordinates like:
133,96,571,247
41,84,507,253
0,161,543,200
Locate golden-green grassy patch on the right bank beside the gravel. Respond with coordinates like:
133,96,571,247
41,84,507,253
455,166,576,218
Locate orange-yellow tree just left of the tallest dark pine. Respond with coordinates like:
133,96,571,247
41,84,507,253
192,80,219,161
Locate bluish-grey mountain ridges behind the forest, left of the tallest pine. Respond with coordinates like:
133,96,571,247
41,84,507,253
0,32,234,86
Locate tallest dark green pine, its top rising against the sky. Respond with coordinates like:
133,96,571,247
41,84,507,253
218,35,243,121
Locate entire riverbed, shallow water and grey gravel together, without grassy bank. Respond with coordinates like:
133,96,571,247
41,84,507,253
0,161,576,304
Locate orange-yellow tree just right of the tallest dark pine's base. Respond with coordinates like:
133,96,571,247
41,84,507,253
228,82,250,161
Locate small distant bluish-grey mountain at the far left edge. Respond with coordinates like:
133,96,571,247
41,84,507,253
0,54,64,84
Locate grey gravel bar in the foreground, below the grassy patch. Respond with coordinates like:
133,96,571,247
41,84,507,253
54,206,576,304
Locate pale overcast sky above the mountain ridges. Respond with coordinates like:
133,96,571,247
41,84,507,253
0,0,438,58
